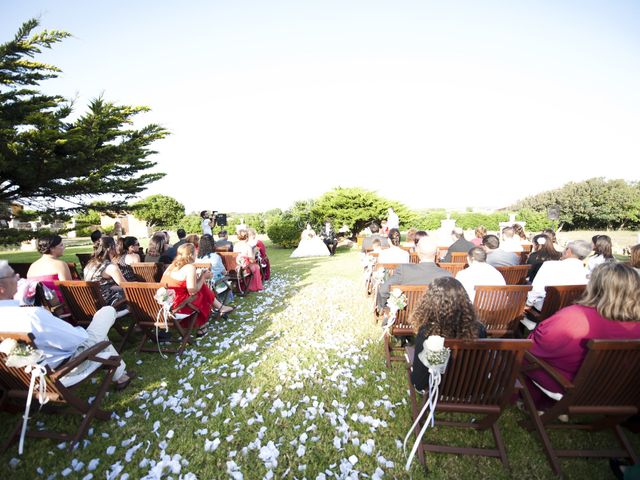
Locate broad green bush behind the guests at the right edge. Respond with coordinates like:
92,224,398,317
514,177,640,230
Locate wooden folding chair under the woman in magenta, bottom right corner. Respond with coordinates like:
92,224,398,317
521,340,640,475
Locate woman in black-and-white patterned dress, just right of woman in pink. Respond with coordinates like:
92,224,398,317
84,235,125,305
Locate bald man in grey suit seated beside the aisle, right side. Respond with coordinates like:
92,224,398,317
376,237,452,311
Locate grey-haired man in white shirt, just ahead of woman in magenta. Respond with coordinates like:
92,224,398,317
527,240,591,310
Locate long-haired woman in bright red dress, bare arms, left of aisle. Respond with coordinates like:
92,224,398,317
161,243,233,334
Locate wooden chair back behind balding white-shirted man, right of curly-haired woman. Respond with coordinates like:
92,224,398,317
473,285,531,338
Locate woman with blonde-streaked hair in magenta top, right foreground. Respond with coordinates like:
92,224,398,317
527,262,640,409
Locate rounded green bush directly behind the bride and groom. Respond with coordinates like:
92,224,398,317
310,187,416,234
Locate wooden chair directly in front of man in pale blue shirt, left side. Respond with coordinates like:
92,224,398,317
54,280,133,352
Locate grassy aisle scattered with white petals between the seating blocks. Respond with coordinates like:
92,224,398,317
10,266,407,480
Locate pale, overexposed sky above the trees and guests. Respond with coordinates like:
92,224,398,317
0,0,640,212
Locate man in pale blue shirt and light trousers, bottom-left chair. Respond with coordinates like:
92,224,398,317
0,260,131,390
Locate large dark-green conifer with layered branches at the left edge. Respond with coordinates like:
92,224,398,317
0,19,168,218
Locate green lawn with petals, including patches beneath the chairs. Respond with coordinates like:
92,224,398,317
0,247,640,479
